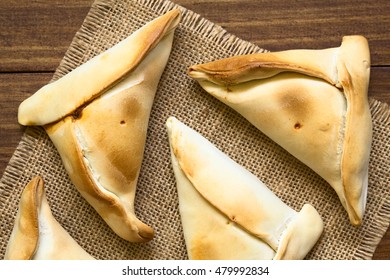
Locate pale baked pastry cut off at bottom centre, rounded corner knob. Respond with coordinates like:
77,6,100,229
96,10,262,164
167,117,323,259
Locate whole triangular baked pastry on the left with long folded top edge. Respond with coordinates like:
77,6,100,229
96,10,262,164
18,9,180,242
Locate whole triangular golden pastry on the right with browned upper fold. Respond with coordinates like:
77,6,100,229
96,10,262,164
188,36,372,226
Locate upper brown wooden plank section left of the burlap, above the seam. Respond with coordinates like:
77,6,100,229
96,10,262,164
0,0,93,72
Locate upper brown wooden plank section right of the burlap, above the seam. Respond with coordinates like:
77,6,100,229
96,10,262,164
177,0,390,66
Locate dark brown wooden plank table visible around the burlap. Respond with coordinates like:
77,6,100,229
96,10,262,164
0,0,390,259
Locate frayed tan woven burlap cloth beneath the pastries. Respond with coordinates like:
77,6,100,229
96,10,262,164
0,0,390,260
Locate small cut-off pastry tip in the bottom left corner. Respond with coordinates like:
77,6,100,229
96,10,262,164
4,176,94,260
